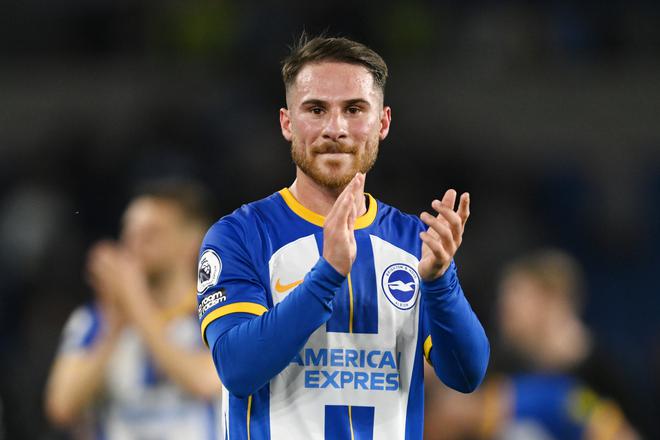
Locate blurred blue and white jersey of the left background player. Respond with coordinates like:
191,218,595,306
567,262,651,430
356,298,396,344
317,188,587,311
59,304,222,440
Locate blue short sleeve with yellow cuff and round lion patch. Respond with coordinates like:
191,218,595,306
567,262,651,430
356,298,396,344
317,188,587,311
197,217,268,341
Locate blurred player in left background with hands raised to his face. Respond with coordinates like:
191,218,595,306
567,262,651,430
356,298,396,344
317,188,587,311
45,180,221,440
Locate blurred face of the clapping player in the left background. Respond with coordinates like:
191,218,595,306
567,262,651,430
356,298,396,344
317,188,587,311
121,197,187,276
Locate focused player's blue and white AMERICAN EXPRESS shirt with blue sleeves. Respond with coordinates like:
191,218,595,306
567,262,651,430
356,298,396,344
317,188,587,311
198,189,488,440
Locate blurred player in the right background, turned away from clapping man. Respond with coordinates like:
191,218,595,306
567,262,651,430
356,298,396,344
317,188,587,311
426,250,638,440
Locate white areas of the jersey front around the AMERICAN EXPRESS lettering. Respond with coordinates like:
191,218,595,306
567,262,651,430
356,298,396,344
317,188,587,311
262,235,419,440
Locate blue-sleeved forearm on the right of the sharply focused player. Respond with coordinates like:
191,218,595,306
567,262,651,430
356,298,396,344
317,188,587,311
422,263,490,392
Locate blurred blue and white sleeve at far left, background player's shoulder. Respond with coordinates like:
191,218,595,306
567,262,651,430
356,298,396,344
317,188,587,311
59,304,101,354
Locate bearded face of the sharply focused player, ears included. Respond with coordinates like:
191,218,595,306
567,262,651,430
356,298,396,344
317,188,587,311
280,62,391,189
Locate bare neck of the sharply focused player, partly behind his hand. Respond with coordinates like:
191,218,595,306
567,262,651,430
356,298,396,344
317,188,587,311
289,168,367,217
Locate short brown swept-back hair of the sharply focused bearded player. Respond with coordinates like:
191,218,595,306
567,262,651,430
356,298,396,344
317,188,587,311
282,32,387,93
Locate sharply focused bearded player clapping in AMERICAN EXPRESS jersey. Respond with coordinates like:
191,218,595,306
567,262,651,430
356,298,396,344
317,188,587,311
198,37,489,440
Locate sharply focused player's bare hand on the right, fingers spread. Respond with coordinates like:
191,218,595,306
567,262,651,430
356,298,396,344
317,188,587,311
417,189,470,281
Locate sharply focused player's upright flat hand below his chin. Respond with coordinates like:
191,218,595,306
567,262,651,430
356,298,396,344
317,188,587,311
323,173,365,276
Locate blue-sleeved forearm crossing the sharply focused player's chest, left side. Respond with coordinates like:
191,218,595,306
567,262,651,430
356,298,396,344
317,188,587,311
206,259,346,397
